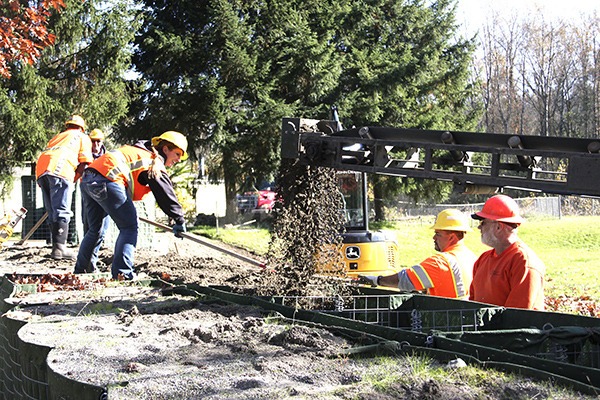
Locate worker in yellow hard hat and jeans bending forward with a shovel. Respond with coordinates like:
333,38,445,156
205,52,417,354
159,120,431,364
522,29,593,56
75,131,188,280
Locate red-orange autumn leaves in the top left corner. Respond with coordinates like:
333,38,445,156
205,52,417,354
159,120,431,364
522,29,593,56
0,0,65,78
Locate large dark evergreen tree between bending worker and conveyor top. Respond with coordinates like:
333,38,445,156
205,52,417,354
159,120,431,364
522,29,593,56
123,0,341,217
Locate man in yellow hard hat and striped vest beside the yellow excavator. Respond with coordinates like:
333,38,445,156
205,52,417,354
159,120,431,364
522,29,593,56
359,209,477,299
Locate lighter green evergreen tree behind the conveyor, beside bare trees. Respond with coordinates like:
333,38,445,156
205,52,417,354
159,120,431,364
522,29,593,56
336,0,480,220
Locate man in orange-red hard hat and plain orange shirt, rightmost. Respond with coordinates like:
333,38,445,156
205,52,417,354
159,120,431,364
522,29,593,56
470,194,546,310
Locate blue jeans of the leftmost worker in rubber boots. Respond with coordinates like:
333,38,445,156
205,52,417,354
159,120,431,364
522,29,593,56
37,174,74,224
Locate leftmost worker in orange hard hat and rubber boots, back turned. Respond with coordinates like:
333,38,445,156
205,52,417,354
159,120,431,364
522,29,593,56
36,115,93,260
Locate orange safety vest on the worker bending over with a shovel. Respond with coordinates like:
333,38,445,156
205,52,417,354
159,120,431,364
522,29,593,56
89,145,165,201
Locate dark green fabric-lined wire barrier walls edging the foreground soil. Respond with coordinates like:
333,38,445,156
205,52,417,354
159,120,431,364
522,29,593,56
0,276,600,400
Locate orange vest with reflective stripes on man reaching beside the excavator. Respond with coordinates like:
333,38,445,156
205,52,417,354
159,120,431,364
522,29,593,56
406,242,477,299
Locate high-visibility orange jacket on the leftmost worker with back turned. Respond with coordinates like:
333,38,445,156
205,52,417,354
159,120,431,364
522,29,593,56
35,129,94,182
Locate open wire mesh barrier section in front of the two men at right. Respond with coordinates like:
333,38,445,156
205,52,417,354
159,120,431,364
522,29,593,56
279,295,600,368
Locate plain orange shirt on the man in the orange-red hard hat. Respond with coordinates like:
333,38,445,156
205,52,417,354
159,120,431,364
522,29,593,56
470,241,546,310
